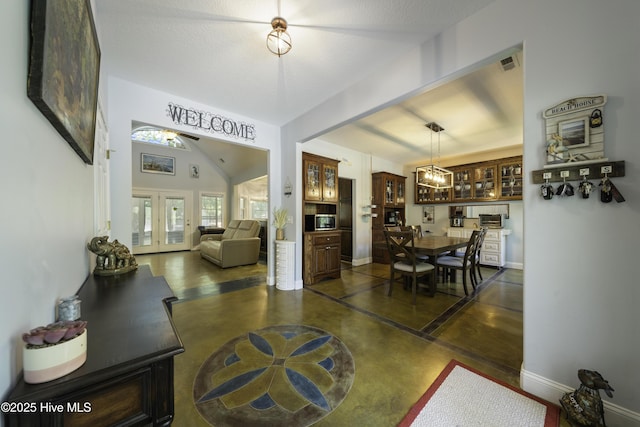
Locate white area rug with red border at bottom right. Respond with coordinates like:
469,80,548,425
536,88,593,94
398,360,560,427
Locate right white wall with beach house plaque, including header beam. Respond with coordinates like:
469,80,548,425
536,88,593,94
283,0,640,425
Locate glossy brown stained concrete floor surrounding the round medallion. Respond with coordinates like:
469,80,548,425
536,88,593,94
136,252,565,426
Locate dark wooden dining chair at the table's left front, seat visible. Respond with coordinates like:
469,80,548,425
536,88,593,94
384,230,436,305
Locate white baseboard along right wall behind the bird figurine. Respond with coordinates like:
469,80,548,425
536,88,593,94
520,369,640,427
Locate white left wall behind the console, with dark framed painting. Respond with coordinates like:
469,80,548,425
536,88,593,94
0,0,99,408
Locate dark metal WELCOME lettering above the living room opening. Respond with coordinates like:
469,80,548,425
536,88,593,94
167,102,256,141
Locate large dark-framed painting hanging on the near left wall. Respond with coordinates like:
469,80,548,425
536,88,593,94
27,0,100,165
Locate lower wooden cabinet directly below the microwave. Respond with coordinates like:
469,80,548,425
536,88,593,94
303,231,341,285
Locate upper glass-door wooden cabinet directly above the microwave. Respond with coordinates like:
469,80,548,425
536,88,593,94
302,153,338,203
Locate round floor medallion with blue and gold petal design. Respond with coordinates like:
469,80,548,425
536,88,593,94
193,325,355,426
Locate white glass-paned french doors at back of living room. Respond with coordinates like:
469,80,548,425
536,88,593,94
131,188,192,255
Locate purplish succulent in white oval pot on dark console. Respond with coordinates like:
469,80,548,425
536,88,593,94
22,320,87,384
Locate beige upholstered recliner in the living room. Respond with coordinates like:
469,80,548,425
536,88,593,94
200,219,260,268
